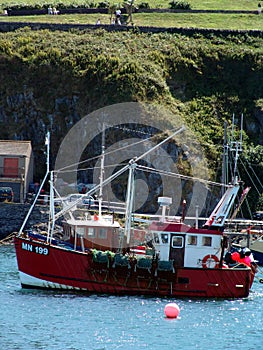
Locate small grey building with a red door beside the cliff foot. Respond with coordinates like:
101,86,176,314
0,140,33,203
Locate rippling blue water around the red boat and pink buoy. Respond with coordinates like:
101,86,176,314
0,245,263,350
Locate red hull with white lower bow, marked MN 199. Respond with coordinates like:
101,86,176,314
15,237,254,298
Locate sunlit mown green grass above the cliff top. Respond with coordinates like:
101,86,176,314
0,0,263,30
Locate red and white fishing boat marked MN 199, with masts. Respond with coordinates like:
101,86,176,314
14,128,256,298
